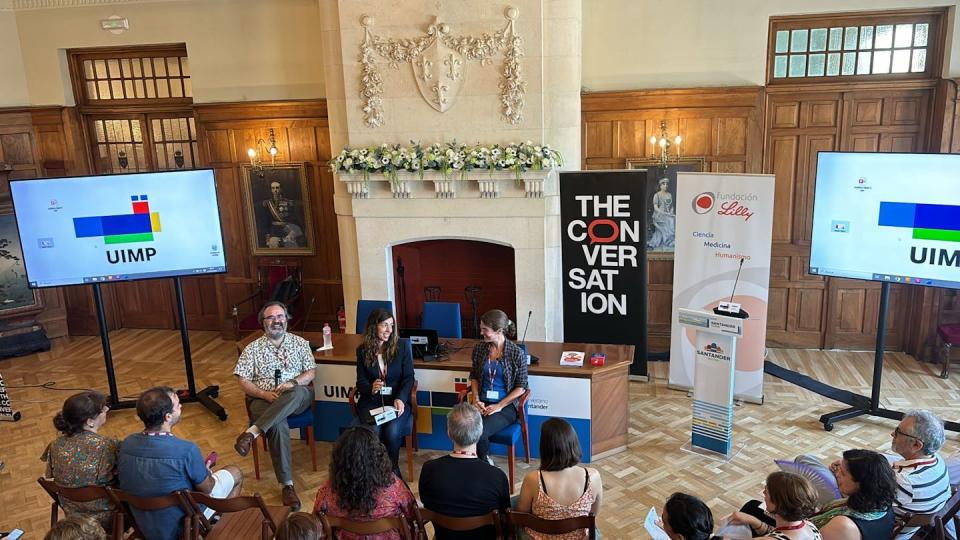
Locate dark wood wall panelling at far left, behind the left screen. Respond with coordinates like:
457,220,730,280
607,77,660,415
0,107,87,338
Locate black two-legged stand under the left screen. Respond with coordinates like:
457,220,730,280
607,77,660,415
93,276,227,421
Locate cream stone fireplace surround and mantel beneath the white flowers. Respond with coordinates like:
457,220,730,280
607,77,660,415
337,171,563,341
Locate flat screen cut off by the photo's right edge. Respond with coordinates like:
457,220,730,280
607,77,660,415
810,152,960,289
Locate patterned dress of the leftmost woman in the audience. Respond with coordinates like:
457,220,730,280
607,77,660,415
40,431,120,530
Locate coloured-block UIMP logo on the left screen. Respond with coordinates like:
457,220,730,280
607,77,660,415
73,195,160,264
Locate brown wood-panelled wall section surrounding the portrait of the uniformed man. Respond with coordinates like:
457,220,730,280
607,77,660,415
194,100,343,336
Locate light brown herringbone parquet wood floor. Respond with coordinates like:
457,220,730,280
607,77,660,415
0,330,960,538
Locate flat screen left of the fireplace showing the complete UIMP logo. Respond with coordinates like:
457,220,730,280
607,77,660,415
10,169,226,288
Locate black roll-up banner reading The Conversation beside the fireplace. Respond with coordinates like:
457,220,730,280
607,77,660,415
560,170,647,376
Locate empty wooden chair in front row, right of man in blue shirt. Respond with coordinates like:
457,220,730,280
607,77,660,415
186,491,290,540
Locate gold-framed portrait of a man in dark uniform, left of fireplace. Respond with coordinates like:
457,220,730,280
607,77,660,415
241,162,316,256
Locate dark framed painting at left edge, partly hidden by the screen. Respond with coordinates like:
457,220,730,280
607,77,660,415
0,204,43,319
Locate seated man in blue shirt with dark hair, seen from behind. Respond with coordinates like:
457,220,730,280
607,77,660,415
118,386,243,540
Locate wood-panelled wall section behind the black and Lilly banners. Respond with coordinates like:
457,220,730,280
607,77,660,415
581,87,764,351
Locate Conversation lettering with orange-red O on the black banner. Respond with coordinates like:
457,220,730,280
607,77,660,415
566,195,644,315
